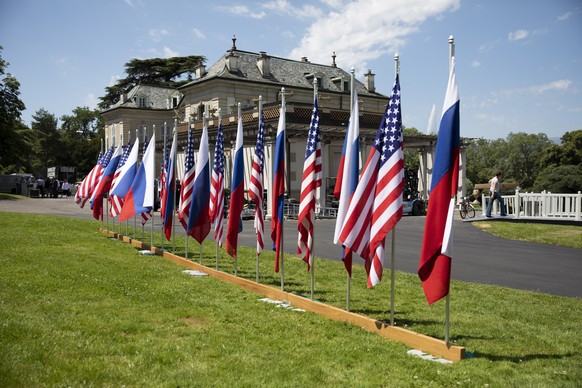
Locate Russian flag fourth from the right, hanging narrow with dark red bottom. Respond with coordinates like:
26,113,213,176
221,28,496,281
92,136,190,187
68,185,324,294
226,105,245,258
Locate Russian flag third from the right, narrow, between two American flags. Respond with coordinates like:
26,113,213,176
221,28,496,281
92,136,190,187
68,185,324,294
271,100,286,272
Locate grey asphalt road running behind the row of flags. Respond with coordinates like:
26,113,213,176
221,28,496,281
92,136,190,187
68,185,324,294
0,198,582,297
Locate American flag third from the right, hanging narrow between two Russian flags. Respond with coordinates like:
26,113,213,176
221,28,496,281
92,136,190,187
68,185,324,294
249,110,265,255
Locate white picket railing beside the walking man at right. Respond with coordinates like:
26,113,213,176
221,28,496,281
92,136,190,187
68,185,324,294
481,190,582,221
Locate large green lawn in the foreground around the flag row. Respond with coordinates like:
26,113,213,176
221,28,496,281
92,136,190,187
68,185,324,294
0,213,582,386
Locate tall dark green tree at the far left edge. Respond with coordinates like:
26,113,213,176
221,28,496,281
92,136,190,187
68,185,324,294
0,46,33,173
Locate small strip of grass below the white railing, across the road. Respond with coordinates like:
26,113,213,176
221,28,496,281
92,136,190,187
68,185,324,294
473,221,582,249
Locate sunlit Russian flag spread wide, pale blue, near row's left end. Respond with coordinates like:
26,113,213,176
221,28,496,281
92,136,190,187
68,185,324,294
119,133,156,222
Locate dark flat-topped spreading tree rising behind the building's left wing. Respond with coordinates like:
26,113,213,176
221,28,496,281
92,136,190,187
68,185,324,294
99,55,206,109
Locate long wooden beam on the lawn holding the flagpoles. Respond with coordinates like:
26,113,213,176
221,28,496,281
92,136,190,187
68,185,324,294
100,229,465,361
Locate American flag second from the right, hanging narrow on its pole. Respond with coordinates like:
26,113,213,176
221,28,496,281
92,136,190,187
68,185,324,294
297,98,321,269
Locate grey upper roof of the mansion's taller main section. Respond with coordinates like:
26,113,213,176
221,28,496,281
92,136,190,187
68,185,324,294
179,50,387,98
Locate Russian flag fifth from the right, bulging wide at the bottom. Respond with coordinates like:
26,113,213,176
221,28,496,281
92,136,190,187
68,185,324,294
187,126,210,244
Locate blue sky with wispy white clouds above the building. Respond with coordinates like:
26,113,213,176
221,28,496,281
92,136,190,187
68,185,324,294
0,0,582,139
